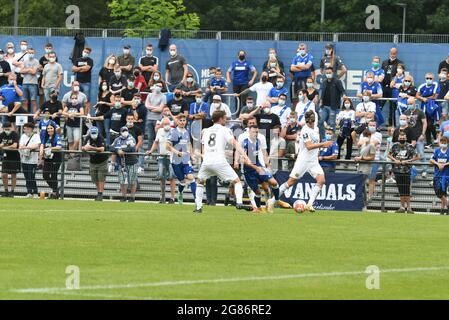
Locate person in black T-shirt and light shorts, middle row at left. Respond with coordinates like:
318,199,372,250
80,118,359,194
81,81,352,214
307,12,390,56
62,94,84,150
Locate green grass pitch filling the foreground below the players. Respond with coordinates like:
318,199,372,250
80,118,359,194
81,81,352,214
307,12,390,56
0,199,449,299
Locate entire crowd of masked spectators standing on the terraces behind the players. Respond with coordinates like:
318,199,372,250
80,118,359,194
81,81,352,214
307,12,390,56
0,41,449,212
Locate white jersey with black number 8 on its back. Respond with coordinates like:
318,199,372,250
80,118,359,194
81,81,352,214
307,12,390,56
202,124,234,165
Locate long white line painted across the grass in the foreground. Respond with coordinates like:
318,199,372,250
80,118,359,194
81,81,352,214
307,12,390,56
10,266,449,294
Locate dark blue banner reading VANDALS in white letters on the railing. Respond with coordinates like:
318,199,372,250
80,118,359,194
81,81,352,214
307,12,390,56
275,171,365,211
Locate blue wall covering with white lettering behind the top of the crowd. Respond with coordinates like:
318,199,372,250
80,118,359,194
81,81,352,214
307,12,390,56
0,35,449,98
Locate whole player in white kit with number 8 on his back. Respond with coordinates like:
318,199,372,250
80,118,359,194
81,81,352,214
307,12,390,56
194,111,249,213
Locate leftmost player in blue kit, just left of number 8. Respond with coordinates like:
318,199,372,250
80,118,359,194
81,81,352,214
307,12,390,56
167,114,196,205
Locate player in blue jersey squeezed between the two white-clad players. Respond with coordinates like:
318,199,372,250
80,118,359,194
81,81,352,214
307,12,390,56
241,126,279,213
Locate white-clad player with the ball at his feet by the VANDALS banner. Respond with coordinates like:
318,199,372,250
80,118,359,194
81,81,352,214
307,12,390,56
279,111,333,212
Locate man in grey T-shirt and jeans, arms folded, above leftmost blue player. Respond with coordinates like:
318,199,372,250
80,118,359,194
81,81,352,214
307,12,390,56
145,82,167,146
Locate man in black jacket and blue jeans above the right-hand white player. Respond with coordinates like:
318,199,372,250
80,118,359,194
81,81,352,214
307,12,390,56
318,67,345,136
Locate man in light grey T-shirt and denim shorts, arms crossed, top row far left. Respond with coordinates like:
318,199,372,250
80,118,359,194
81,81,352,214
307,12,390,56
20,48,40,113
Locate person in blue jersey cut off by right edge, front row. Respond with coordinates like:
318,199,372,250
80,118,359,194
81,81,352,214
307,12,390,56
430,136,449,215
